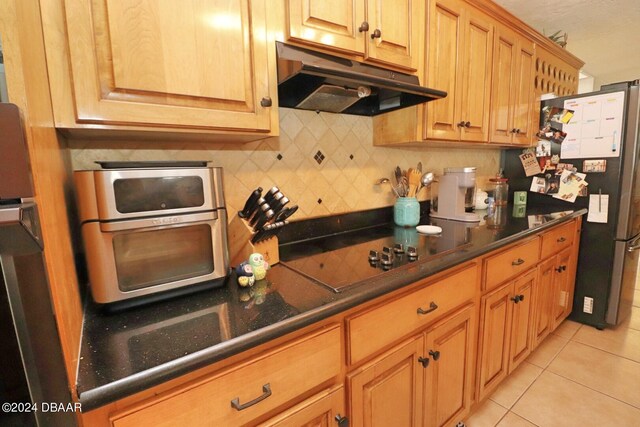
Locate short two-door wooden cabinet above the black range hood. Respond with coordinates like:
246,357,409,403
287,0,424,72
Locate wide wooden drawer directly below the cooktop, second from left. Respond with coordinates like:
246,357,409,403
347,264,478,364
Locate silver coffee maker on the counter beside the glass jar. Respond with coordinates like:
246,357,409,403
431,167,480,222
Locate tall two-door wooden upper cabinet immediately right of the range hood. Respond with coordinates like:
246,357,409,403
424,0,493,142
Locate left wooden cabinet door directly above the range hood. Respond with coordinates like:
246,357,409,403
287,0,369,55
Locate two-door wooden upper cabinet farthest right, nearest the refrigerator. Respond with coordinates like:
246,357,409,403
489,26,537,145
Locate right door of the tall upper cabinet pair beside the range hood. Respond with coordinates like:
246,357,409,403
460,9,493,142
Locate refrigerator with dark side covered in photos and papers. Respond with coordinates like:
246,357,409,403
501,80,640,329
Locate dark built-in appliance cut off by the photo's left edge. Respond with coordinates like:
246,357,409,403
0,103,76,427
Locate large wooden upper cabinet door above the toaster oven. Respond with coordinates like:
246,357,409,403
65,0,277,131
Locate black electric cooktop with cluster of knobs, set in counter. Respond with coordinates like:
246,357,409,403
279,220,477,292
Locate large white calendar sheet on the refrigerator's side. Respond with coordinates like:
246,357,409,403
560,91,624,159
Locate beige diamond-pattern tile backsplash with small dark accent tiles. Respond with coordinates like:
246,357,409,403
69,108,500,219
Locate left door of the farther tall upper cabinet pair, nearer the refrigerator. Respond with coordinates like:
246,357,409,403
489,27,517,143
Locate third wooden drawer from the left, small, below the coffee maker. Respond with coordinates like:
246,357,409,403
482,237,540,291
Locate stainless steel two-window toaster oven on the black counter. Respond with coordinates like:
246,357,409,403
74,166,229,304
